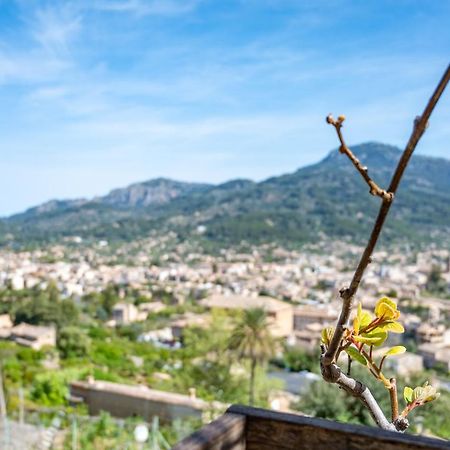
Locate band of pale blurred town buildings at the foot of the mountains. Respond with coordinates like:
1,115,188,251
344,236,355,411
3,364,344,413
0,243,450,365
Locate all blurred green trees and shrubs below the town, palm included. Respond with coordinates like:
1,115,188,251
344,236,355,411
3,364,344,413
0,285,450,442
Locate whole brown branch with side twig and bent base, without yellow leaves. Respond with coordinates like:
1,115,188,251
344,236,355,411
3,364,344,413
320,65,450,431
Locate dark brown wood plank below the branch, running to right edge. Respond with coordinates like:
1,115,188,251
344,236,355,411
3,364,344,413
227,405,450,450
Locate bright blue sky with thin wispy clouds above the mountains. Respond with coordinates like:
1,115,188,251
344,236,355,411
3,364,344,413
0,0,450,215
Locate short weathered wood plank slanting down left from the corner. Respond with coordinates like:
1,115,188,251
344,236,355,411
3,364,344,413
172,413,246,450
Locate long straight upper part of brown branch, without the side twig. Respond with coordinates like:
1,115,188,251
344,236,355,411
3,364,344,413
323,65,450,366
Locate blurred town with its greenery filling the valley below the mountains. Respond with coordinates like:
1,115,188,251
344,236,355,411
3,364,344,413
0,232,450,448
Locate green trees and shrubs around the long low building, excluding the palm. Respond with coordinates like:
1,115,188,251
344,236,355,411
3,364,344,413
0,286,278,449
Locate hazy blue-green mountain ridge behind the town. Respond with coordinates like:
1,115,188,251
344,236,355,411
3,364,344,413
0,143,450,243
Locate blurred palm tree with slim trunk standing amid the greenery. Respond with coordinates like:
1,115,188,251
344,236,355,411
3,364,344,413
228,308,276,405
